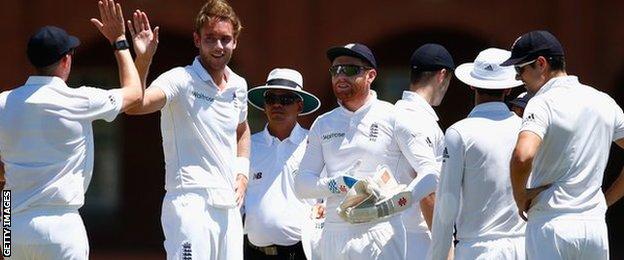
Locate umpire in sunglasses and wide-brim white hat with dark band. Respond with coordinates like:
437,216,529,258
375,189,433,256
244,68,321,259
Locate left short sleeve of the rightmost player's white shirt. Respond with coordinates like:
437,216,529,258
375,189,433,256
520,96,550,139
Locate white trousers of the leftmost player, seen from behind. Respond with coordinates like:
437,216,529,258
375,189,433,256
6,209,89,260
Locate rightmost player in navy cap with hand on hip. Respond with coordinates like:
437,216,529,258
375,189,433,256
502,31,624,259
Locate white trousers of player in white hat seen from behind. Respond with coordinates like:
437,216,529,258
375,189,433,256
455,236,526,260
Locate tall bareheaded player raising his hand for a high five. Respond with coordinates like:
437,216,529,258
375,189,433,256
124,0,250,259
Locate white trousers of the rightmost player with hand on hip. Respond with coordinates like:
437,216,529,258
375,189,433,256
526,217,609,260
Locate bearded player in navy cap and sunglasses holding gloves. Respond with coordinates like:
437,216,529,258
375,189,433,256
295,43,406,259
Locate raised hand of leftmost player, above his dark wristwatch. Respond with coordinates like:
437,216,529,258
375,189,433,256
91,0,126,44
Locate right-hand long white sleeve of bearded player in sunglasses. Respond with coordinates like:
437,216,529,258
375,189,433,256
394,112,440,201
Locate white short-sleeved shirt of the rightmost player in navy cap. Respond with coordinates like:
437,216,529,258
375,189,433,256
522,76,624,220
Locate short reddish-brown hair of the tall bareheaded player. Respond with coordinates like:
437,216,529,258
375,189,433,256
195,0,243,38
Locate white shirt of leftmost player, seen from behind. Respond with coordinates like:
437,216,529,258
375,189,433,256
0,76,123,213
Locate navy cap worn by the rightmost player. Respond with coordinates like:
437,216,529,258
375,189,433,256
501,31,563,66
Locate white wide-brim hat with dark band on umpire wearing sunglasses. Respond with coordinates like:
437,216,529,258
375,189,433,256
247,69,321,116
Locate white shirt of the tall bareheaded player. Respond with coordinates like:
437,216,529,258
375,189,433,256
151,57,247,207
